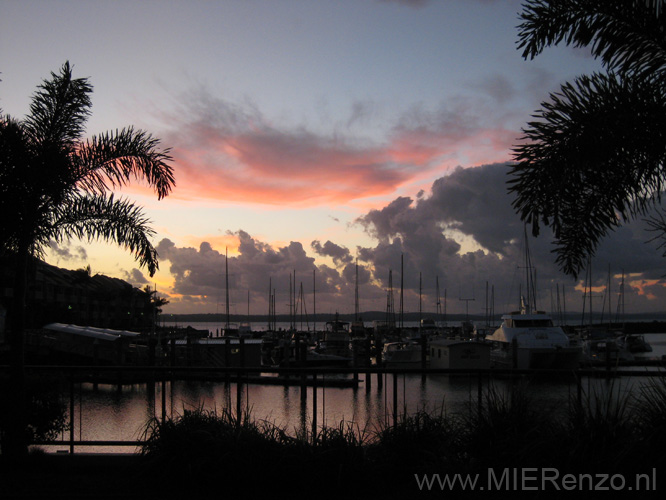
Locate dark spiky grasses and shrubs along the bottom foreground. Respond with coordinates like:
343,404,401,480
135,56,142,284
135,378,666,498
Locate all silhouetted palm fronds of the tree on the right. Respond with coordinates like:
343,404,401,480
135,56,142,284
508,0,666,277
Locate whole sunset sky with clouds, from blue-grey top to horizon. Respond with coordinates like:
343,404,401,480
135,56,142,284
0,0,666,317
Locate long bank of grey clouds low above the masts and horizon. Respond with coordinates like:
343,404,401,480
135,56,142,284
150,164,666,314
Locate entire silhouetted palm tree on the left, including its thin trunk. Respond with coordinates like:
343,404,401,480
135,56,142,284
0,62,175,454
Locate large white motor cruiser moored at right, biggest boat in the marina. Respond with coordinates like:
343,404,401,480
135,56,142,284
486,301,582,370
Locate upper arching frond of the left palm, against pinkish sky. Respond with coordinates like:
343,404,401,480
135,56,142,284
75,127,175,199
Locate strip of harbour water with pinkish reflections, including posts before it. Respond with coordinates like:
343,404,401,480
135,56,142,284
18,334,666,453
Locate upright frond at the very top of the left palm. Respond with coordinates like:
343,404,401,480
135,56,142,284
25,62,92,147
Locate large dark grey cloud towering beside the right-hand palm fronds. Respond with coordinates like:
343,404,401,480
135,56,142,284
357,164,663,309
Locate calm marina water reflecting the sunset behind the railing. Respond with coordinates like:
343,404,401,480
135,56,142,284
39,334,666,453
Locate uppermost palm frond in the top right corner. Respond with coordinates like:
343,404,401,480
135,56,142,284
518,0,666,79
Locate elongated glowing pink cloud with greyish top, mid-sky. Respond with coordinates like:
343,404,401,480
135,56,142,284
160,90,518,206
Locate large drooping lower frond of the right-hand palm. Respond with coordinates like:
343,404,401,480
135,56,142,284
508,74,666,276
